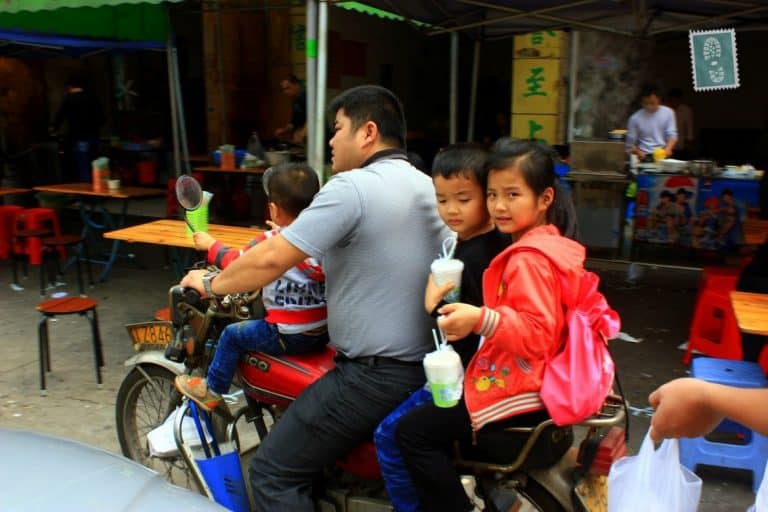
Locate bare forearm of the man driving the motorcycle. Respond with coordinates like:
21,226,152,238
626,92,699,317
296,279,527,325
211,235,307,295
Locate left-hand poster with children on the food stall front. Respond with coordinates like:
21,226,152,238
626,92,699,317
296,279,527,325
635,175,698,247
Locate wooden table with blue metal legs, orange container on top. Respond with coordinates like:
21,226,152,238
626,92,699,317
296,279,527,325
35,183,166,281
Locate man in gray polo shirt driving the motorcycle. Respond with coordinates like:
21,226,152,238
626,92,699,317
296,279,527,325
181,86,449,512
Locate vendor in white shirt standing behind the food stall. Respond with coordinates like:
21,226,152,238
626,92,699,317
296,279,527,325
626,85,677,161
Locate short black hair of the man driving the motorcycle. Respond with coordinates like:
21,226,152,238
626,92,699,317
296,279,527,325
328,85,405,149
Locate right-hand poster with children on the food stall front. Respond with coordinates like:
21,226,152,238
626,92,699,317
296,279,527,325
691,178,759,251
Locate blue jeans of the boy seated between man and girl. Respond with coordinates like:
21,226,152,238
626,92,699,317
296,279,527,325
373,387,432,512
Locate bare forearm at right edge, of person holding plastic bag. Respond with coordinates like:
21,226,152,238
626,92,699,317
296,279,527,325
706,384,768,436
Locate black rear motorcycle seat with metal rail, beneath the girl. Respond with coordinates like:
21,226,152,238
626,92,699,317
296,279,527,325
456,411,574,472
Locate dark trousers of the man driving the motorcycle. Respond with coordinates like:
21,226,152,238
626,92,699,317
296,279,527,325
250,358,424,512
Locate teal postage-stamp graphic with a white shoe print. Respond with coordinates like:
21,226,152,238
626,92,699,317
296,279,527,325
689,29,739,91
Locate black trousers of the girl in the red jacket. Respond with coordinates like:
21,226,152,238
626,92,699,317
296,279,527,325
395,399,548,512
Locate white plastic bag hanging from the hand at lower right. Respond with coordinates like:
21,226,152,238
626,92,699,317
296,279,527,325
608,434,701,512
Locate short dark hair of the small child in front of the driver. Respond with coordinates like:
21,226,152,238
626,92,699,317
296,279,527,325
262,162,320,217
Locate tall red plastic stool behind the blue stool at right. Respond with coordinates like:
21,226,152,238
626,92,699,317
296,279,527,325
683,288,743,364
